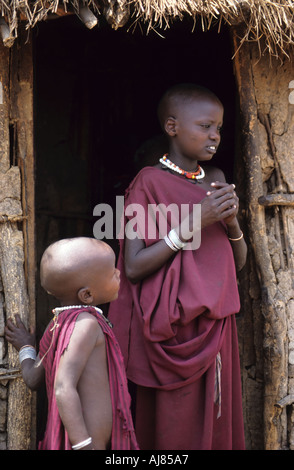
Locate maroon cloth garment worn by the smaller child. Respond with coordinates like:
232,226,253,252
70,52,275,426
39,307,138,450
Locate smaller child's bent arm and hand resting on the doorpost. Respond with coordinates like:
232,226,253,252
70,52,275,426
5,315,45,390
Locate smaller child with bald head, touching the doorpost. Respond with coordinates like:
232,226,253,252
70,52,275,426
6,237,137,450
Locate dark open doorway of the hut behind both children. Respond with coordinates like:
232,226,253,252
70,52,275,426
35,16,237,438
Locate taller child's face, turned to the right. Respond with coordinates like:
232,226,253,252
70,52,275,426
172,99,223,161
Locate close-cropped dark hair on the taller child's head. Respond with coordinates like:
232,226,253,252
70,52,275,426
157,83,222,130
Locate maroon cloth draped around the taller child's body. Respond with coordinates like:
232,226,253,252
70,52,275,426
109,167,244,449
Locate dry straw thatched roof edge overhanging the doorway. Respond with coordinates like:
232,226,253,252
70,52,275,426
0,0,294,55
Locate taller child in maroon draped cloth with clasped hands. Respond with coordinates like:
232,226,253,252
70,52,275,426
109,84,247,450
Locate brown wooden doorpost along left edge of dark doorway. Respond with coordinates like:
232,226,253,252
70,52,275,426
10,26,36,326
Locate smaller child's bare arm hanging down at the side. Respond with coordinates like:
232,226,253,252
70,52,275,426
54,313,104,450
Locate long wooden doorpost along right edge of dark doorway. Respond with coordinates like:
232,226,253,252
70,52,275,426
233,31,288,450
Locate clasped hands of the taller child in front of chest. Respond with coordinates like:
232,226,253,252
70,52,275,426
201,181,239,227
